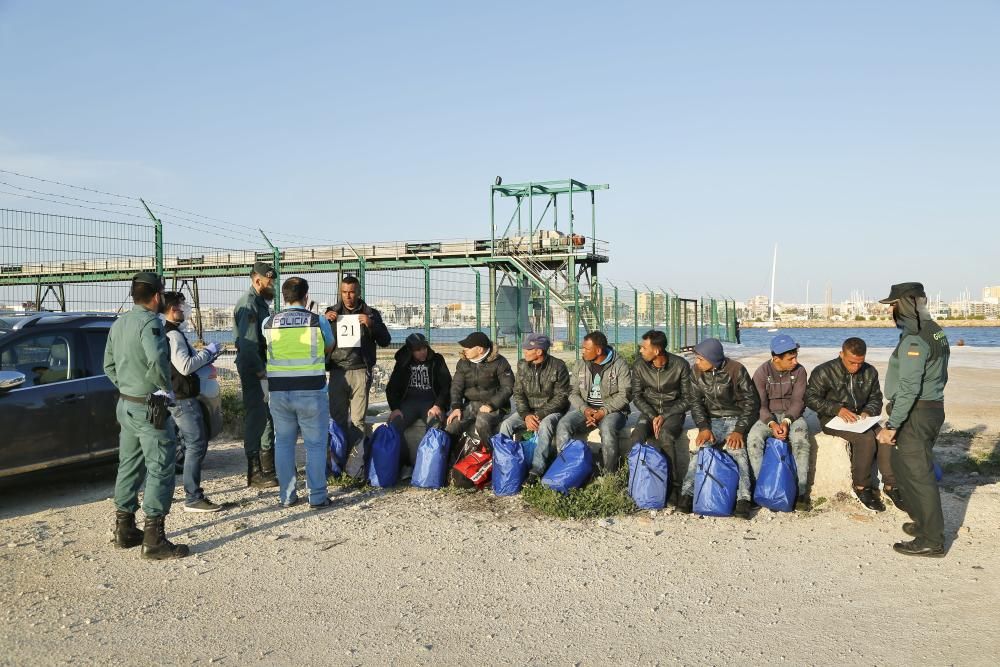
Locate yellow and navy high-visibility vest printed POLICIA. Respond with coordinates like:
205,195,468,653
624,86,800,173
263,308,326,391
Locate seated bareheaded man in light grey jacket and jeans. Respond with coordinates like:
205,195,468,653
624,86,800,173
556,331,632,473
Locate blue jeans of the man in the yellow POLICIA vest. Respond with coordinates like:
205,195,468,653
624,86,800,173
270,389,330,505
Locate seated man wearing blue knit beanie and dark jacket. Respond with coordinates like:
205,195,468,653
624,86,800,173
677,338,760,519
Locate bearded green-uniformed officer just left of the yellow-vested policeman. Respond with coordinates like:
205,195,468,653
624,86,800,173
233,262,278,488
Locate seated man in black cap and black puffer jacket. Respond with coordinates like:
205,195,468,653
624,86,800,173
445,331,514,458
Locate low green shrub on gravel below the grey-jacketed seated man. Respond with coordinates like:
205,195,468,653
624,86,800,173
521,466,636,519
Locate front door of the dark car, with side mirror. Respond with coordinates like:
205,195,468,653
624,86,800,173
0,330,90,474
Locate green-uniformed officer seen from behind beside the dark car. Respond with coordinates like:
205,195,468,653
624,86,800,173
104,273,188,560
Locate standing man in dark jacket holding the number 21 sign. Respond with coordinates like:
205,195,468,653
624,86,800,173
326,276,392,478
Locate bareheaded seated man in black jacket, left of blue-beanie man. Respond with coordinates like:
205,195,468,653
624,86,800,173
632,331,691,505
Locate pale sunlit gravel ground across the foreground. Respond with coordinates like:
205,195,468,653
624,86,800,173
0,353,1000,665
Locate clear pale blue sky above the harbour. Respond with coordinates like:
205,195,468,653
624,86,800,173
0,0,1000,303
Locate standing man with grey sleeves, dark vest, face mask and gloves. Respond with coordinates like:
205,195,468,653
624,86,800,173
163,292,222,512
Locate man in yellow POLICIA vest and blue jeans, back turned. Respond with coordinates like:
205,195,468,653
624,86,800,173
263,278,334,509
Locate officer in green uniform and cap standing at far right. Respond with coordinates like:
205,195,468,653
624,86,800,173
878,283,950,558
